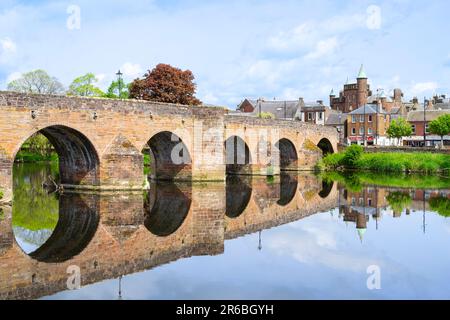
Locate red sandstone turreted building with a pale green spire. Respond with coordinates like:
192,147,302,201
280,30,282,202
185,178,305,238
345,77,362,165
330,65,403,113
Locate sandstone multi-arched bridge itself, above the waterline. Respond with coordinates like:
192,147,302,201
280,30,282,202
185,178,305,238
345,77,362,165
0,92,338,204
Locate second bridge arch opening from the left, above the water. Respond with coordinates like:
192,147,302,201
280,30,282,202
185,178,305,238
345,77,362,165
148,131,192,180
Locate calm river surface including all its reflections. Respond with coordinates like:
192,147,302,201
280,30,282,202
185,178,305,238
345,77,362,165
0,164,450,299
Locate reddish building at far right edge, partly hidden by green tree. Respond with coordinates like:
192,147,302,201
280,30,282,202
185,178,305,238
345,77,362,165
403,106,450,147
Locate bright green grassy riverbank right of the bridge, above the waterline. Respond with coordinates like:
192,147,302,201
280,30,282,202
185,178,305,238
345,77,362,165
318,145,450,175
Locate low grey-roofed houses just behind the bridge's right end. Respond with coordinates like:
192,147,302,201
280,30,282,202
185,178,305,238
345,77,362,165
237,98,335,125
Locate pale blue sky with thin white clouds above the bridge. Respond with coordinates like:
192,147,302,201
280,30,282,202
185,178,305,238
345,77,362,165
0,0,450,109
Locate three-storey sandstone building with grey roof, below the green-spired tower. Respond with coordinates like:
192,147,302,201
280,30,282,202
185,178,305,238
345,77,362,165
347,104,394,146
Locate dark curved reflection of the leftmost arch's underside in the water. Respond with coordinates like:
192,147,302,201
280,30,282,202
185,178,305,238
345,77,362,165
29,194,100,263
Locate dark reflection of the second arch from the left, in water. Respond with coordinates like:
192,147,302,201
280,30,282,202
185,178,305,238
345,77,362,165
144,183,192,237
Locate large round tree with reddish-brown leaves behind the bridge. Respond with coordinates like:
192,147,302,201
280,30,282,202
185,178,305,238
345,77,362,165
130,64,201,105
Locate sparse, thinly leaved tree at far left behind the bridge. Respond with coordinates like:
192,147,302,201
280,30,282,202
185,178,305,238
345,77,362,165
8,69,64,94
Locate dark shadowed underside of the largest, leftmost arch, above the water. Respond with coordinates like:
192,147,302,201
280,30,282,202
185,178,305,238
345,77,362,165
14,125,99,185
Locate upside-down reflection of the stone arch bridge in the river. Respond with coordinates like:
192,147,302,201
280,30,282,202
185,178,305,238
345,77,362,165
0,173,338,299
